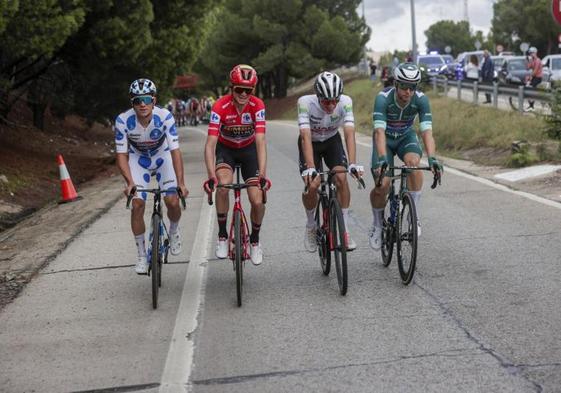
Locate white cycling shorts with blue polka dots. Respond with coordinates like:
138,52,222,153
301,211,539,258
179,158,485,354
129,150,177,200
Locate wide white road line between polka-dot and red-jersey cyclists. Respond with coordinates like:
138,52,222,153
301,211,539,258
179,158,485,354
159,139,214,393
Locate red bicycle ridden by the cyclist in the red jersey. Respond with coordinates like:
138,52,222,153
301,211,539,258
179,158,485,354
208,164,267,307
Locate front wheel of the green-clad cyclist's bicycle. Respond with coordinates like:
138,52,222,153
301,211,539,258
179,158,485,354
397,192,417,285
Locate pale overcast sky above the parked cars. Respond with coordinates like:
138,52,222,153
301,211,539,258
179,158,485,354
358,0,494,52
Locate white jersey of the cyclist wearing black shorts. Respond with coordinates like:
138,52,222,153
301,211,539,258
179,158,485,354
298,94,355,142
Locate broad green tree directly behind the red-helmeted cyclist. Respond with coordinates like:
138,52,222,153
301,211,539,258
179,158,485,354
196,0,370,97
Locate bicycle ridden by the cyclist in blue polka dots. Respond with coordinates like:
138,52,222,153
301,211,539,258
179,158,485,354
127,186,185,309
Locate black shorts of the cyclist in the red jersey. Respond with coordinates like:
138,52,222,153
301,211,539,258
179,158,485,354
216,142,259,183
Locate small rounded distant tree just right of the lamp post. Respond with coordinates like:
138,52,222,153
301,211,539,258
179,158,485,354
425,20,475,56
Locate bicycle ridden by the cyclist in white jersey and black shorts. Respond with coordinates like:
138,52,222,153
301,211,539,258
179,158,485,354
304,166,365,296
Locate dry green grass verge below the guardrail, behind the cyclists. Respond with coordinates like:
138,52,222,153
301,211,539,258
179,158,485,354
283,79,561,166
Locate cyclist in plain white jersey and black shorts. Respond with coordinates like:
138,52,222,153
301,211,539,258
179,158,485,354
298,72,364,252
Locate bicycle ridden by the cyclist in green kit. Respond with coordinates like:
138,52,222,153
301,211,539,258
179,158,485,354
376,164,441,285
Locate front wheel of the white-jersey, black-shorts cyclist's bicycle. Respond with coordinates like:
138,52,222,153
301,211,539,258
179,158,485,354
329,199,347,296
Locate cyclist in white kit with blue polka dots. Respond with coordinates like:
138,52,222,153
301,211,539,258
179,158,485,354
115,79,189,274
